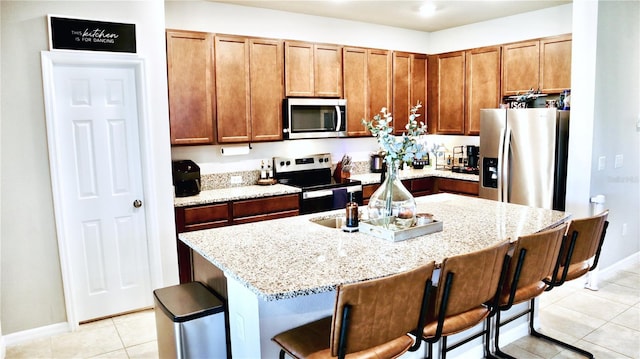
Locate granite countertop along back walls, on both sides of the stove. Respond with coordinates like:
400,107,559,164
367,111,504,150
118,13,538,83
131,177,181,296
173,167,479,207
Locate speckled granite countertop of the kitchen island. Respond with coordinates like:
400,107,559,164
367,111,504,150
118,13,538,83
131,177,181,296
179,193,569,301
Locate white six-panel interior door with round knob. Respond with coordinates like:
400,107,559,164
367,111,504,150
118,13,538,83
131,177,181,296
45,57,152,322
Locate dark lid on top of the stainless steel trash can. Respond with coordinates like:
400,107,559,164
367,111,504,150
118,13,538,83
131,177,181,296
153,282,224,323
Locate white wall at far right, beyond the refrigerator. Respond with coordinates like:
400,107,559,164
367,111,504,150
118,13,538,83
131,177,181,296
588,1,640,267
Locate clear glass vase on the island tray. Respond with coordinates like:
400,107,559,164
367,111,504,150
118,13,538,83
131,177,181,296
367,162,416,230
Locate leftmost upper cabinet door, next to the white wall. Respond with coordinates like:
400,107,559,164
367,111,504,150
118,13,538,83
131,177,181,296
167,30,215,145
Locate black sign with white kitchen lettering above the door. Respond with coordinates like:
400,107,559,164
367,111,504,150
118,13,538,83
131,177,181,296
49,16,136,53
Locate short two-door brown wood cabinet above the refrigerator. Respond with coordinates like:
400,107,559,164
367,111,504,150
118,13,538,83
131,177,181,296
502,35,571,96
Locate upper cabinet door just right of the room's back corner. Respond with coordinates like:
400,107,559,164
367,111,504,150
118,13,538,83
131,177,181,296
429,51,465,135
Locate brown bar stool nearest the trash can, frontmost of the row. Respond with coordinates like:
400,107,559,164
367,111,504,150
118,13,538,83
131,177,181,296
272,262,434,358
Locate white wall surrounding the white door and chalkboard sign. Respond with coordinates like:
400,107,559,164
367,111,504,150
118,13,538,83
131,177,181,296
0,0,177,335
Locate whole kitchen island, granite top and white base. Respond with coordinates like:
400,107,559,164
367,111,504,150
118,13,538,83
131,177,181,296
179,194,569,358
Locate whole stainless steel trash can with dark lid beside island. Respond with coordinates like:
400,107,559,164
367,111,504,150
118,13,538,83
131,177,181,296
153,282,227,359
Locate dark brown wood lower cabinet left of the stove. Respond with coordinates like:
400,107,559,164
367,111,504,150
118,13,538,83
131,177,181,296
175,194,300,283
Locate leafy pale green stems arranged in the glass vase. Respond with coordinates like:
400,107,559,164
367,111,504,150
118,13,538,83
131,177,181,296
362,101,427,165
